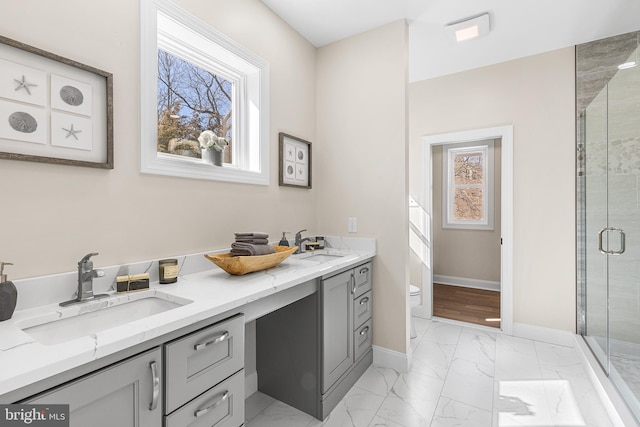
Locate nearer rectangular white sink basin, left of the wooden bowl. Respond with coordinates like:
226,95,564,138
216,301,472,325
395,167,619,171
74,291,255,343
16,291,192,345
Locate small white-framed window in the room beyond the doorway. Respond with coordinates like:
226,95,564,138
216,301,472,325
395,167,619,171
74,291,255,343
442,141,493,230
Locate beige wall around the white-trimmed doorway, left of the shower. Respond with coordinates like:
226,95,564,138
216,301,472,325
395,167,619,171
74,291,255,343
409,48,576,331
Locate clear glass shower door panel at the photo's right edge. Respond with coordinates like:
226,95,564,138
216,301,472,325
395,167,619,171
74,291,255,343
607,51,640,418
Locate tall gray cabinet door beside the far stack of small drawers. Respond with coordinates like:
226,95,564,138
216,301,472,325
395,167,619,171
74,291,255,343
321,270,353,394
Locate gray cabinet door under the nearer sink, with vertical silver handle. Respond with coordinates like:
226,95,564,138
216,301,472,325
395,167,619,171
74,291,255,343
25,348,162,427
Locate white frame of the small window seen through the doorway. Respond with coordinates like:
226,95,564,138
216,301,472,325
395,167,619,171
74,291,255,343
442,140,494,230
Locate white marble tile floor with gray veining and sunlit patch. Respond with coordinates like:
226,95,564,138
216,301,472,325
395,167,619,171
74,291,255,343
245,318,613,427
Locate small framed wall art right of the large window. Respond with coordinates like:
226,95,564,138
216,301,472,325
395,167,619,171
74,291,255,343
278,132,311,188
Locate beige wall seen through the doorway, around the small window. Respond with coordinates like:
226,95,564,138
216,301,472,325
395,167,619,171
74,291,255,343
431,140,502,282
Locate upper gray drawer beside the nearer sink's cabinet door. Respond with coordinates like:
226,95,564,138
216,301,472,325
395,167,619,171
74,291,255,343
165,315,244,414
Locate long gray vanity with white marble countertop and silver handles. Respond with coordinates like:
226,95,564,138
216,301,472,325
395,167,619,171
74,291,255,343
0,239,375,426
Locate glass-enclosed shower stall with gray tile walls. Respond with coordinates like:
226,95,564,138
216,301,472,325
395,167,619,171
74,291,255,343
576,32,640,420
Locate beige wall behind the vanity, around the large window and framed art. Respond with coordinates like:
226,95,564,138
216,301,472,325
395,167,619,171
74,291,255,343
0,0,320,279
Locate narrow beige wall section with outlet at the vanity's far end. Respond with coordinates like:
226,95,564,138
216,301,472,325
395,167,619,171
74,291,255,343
314,21,408,353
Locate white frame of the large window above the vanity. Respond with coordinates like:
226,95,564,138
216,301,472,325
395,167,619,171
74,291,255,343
140,0,269,185
